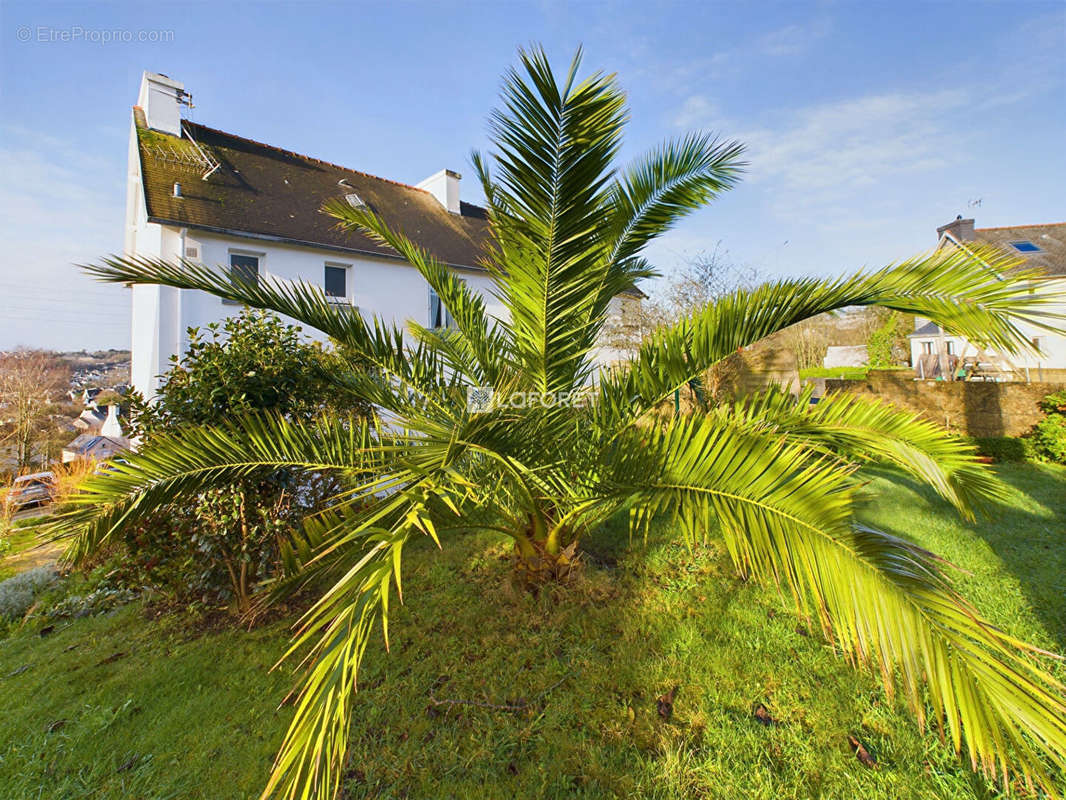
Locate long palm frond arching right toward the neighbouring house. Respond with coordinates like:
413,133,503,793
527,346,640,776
600,247,1064,426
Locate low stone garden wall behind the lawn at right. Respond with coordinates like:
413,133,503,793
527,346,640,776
825,370,1066,436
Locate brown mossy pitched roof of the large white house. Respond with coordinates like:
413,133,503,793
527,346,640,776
133,107,488,268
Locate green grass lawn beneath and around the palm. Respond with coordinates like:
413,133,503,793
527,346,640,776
0,465,1066,800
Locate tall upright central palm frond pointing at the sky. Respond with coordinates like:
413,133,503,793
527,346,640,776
487,45,626,393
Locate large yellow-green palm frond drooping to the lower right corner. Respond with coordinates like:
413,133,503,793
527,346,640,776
592,415,1066,791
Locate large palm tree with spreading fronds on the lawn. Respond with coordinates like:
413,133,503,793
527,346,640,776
61,50,1066,798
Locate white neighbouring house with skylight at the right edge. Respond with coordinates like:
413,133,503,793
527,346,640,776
908,217,1066,381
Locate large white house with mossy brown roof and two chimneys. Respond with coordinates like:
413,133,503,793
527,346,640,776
125,73,639,398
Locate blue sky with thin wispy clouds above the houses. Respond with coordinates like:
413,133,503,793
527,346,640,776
0,0,1066,349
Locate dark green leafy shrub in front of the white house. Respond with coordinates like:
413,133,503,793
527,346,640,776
125,308,362,614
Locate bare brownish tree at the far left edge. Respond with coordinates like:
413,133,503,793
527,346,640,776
0,349,70,471
